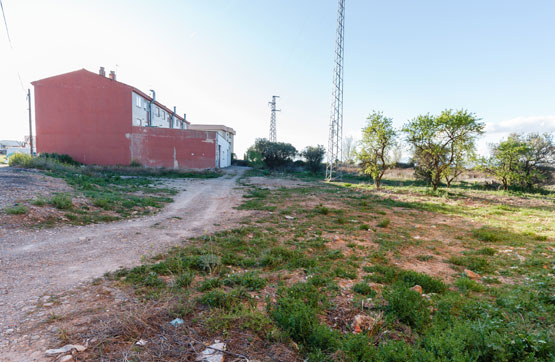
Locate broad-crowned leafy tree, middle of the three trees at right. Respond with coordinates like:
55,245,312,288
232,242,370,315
403,109,484,190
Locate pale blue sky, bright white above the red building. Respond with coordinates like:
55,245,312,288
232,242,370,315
0,0,555,158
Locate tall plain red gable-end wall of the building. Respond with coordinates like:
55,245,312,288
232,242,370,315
33,70,132,165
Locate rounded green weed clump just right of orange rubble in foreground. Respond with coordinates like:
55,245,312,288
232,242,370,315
383,283,430,329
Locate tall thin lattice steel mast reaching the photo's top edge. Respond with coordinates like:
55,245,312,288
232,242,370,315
326,0,345,180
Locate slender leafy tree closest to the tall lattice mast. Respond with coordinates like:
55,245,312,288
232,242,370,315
356,112,397,189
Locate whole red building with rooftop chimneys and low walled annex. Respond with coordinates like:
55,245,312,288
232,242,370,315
32,68,235,169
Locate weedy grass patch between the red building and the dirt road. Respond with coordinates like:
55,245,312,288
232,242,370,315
4,157,221,227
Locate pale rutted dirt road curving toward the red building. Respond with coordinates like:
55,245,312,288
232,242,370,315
0,168,246,347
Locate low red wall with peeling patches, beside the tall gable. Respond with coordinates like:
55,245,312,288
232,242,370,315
128,127,216,169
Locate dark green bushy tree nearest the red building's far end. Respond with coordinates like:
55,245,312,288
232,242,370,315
247,138,297,169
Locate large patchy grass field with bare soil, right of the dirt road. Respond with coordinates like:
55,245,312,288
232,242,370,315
67,171,555,362
